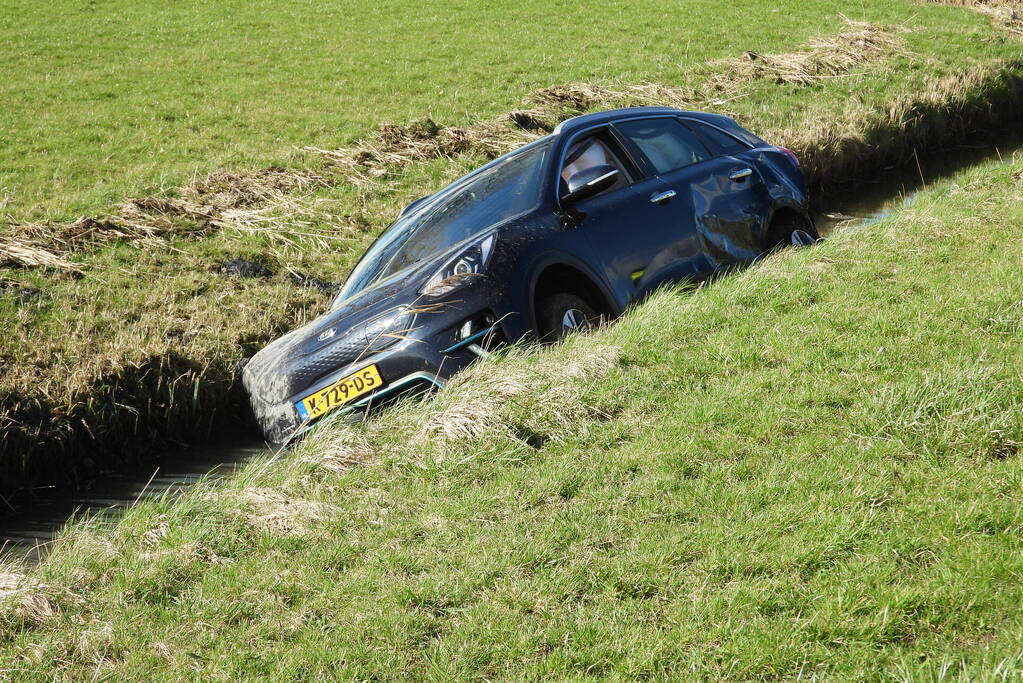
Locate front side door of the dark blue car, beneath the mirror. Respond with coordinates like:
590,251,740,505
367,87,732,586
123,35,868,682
559,127,674,305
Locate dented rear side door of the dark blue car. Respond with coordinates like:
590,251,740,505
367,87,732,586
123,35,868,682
615,117,770,291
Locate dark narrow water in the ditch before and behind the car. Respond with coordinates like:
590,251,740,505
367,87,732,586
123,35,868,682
0,132,1023,563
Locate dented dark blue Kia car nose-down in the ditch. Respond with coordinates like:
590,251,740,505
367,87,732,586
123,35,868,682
243,107,816,443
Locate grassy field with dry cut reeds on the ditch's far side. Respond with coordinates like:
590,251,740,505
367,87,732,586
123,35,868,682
0,0,1023,495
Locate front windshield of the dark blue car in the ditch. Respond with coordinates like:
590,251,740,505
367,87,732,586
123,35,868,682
336,140,551,302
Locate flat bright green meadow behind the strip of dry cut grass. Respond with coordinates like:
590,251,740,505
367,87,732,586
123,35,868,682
0,0,1016,219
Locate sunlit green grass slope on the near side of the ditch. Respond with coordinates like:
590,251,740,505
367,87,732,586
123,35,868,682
0,160,1023,680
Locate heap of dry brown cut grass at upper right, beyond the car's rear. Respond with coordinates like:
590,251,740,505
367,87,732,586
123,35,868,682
711,19,905,90
